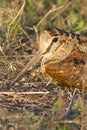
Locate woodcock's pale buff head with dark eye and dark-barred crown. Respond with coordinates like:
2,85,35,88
39,27,77,64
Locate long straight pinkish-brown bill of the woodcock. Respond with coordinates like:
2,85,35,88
11,51,42,86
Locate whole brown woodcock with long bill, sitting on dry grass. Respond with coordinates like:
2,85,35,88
12,27,87,89
